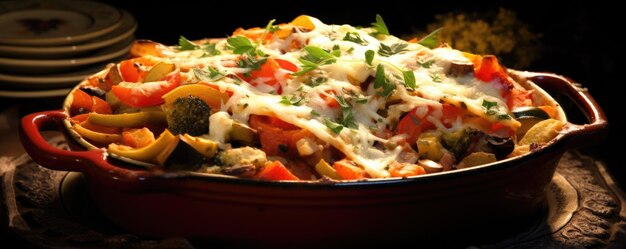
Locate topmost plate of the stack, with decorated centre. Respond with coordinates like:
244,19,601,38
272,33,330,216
0,0,121,46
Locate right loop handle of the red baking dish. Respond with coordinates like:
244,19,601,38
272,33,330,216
521,72,609,148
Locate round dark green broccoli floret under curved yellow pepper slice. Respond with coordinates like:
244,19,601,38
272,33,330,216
165,95,211,136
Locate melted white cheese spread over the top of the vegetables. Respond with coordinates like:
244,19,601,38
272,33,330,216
155,17,520,177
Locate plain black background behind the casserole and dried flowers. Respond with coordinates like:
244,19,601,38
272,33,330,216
107,0,626,185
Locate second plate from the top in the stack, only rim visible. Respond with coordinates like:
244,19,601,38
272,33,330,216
0,11,137,59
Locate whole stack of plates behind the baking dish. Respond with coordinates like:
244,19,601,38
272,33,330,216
0,0,137,98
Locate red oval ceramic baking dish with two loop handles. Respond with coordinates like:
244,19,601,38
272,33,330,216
20,70,608,247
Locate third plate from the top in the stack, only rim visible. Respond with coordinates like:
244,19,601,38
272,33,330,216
0,36,134,75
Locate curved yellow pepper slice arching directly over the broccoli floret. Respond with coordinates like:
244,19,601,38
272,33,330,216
163,84,228,110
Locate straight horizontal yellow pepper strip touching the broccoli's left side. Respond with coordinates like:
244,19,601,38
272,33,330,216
87,111,167,127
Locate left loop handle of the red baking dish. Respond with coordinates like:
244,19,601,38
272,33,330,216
19,110,106,172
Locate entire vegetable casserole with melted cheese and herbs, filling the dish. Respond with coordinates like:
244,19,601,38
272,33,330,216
69,15,564,181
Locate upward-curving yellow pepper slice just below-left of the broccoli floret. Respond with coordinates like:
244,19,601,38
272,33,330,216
108,129,179,164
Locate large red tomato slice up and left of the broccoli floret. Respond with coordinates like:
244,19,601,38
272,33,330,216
111,71,180,107
